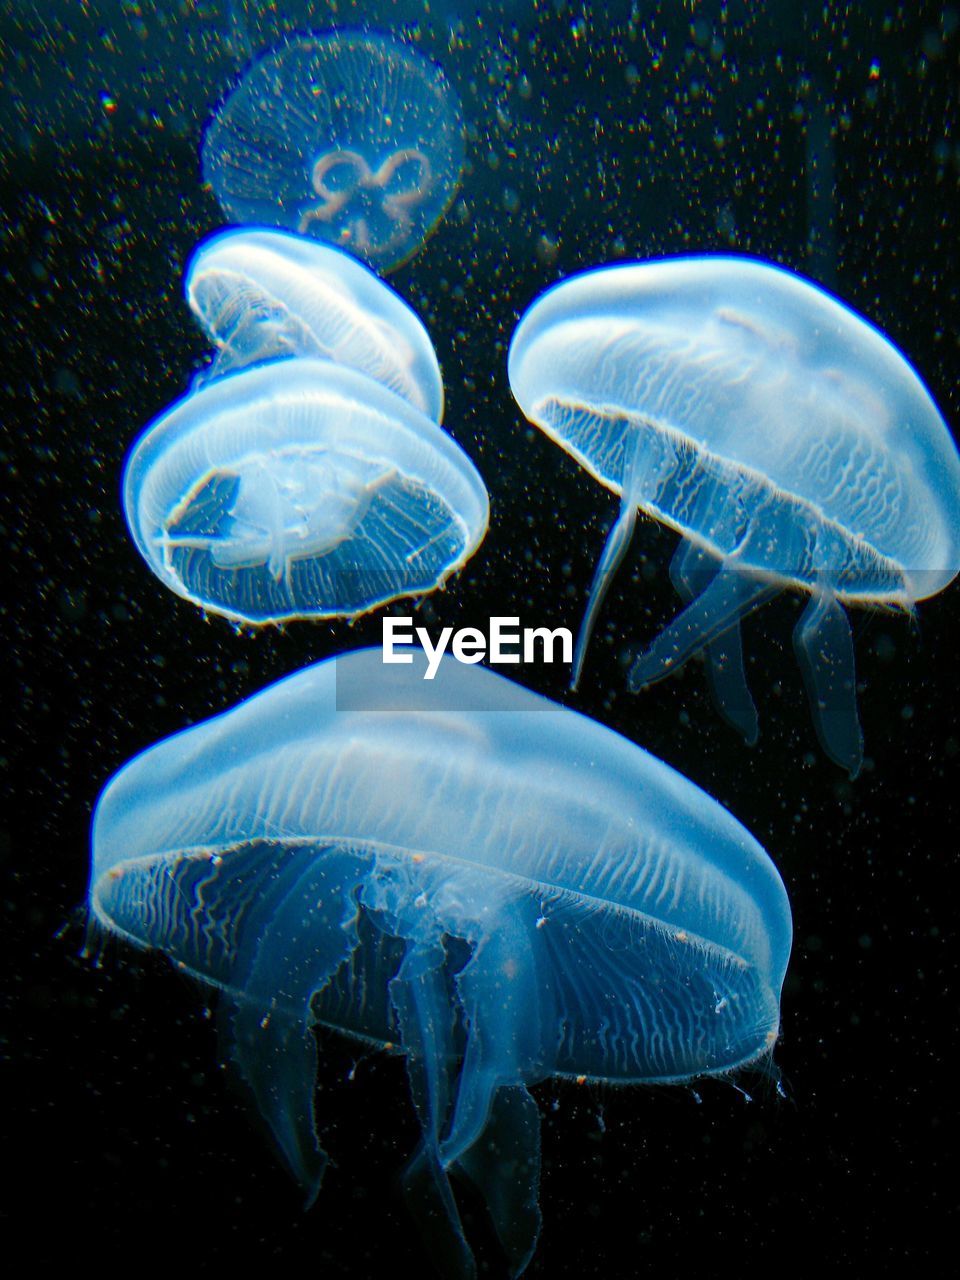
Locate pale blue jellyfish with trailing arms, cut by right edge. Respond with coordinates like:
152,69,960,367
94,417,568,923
509,249,960,777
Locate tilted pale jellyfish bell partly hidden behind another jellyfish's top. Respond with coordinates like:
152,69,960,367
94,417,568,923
186,227,443,422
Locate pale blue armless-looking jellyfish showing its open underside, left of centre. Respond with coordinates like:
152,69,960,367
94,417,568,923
123,358,489,625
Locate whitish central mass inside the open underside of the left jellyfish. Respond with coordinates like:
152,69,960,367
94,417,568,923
157,449,396,591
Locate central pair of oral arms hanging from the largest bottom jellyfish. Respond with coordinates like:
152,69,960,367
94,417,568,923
360,851,549,1276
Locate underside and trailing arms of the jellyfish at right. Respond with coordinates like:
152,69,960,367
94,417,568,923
572,419,906,778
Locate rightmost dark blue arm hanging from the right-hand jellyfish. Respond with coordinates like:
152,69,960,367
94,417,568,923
794,586,863,781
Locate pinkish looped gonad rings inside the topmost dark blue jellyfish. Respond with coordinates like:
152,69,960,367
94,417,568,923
297,147,433,261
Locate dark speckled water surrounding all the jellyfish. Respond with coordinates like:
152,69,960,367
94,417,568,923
0,0,960,1277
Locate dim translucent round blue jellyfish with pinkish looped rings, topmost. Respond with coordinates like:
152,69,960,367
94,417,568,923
202,32,463,271
